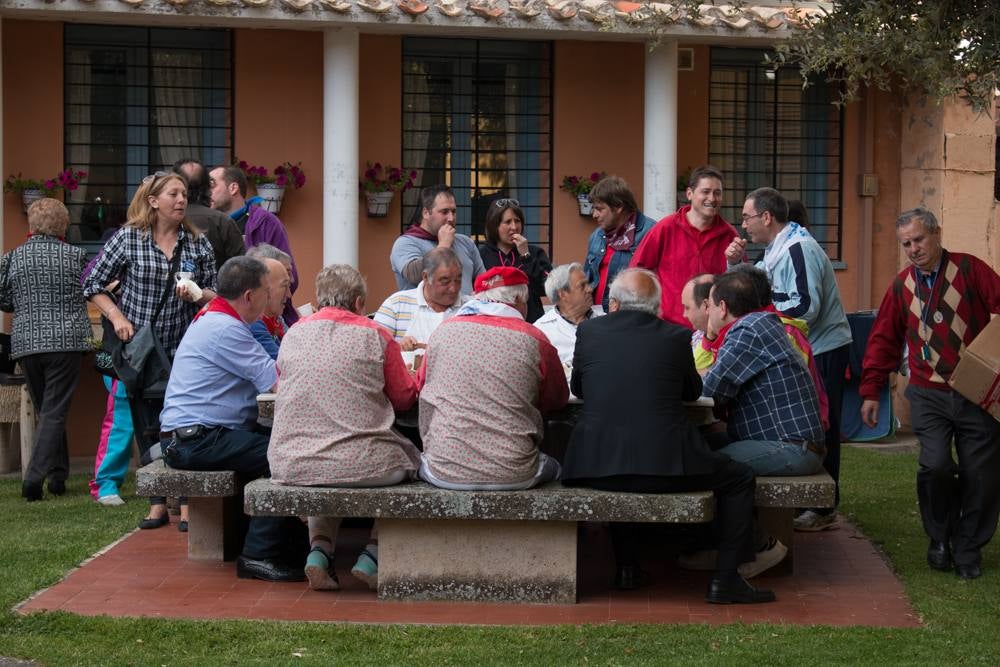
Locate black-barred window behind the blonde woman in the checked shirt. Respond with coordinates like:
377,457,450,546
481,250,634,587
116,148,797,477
64,24,232,250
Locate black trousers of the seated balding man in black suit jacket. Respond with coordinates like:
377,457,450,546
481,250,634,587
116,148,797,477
563,461,756,574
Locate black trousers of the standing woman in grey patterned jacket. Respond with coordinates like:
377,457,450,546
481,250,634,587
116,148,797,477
20,352,83,484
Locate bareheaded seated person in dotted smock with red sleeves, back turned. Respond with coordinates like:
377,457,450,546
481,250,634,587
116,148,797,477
267,264,420,590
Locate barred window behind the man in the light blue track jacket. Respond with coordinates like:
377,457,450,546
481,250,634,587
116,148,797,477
708,48,843,261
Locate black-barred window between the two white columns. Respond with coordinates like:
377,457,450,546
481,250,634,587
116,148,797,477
401,37,552,255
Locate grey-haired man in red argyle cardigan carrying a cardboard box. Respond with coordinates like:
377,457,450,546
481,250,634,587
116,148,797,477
860,207,1000,579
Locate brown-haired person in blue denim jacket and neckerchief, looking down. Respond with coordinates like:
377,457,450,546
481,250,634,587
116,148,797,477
583,176,656,312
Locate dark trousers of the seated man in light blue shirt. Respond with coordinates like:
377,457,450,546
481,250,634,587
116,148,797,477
161,427,309,564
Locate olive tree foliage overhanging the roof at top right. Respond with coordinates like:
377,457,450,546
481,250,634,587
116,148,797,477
769,0,1000,112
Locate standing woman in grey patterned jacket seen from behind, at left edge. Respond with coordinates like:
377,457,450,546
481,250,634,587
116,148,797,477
0,198,91,502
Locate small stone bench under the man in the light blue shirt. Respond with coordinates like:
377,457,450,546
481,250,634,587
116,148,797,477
136,460,240,561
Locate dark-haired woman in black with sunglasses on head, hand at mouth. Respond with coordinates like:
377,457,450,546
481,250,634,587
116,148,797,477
479,199,552,322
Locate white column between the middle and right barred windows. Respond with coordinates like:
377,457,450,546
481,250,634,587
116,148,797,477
641,40,677,220
